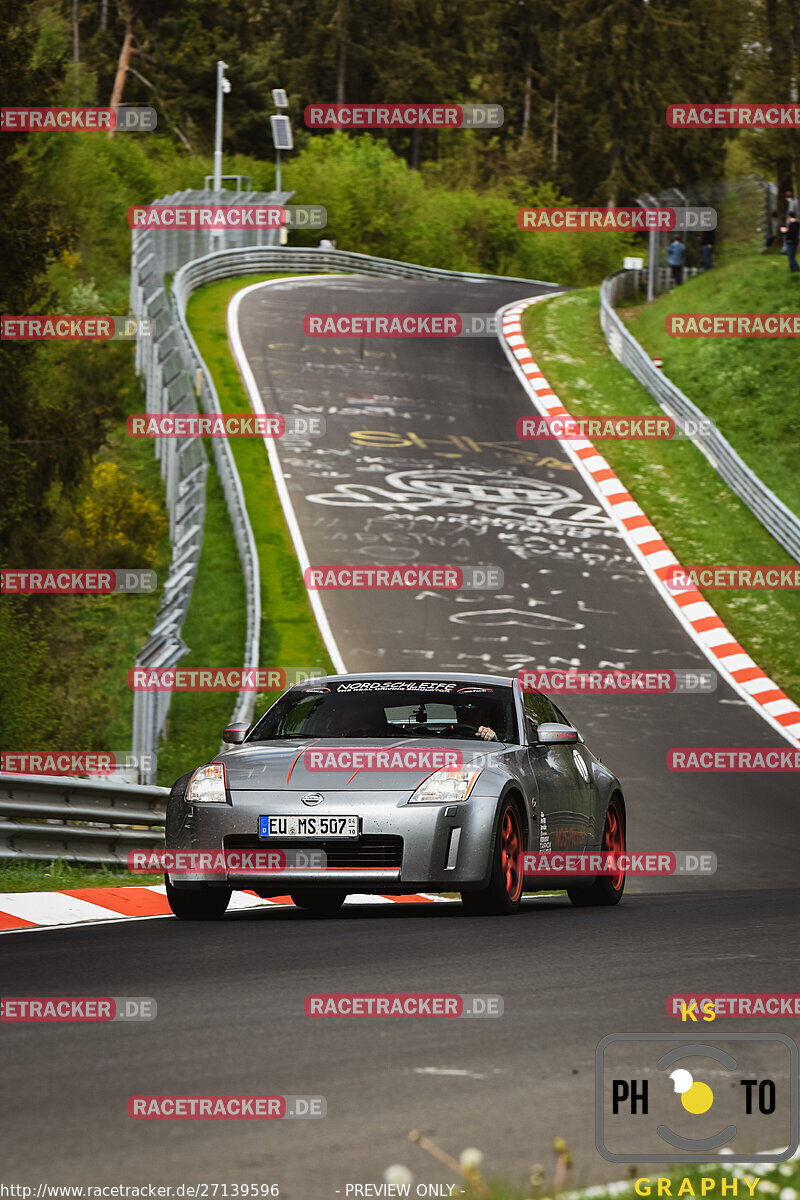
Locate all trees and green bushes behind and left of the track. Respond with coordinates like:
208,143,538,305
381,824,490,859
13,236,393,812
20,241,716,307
0,0,800,739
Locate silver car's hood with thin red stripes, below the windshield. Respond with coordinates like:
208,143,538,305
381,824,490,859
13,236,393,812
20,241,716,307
213,738,506,792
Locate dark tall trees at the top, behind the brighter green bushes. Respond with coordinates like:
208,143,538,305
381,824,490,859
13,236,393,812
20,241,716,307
42,0,800,203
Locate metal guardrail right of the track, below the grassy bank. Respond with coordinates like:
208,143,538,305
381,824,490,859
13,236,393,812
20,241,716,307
600,271,800,562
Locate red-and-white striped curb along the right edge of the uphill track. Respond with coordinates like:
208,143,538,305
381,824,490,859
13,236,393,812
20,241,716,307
499,296,800,745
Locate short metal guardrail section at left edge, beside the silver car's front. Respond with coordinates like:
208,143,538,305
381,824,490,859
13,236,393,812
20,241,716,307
0,775,169,866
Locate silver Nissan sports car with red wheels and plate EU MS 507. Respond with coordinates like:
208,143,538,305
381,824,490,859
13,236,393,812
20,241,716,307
167,672,626,920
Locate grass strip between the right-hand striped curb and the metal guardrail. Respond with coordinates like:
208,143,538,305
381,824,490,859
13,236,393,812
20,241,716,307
523,284,800,703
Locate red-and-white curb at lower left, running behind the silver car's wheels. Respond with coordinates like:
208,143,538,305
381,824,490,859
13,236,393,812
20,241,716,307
0,883,457,934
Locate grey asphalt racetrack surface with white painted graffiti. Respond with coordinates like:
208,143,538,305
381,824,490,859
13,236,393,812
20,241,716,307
0,278,800,1200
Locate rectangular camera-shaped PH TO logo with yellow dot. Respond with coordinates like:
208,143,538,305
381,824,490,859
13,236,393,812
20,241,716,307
595,1031,800,1163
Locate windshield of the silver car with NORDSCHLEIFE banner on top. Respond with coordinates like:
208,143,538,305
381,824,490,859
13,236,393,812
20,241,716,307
247,679,518,743
